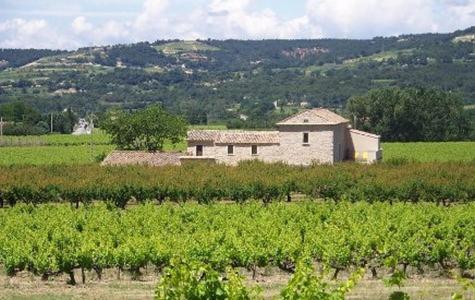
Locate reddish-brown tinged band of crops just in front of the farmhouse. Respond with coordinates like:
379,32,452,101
0,162,475,208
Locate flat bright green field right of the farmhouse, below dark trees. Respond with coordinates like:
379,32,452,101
382,142,475,162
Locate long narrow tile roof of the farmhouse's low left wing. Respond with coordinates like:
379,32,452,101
188,130,279,144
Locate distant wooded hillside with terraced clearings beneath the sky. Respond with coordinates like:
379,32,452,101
0,27,475,127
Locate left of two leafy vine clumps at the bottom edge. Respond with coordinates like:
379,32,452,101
155,258,257,300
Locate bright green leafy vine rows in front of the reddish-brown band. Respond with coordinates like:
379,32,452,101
0,201,475,299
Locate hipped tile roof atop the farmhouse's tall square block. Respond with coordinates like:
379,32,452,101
277,108,349,125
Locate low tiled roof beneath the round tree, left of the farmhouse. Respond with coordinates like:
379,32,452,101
101,151,182,167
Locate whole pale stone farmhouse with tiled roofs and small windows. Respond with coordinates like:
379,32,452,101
180,108,382,165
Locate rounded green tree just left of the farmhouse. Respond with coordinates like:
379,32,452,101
101,105,187,151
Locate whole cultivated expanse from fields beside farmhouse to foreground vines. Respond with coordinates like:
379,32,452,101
0,143,475,299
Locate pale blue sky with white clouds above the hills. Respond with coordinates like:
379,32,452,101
0,0,475,49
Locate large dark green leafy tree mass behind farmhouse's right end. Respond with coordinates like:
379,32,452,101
347,88,470,141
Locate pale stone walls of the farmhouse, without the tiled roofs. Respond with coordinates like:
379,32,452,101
187,123,381,165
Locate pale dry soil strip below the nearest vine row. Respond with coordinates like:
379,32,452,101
0,267,475,300
